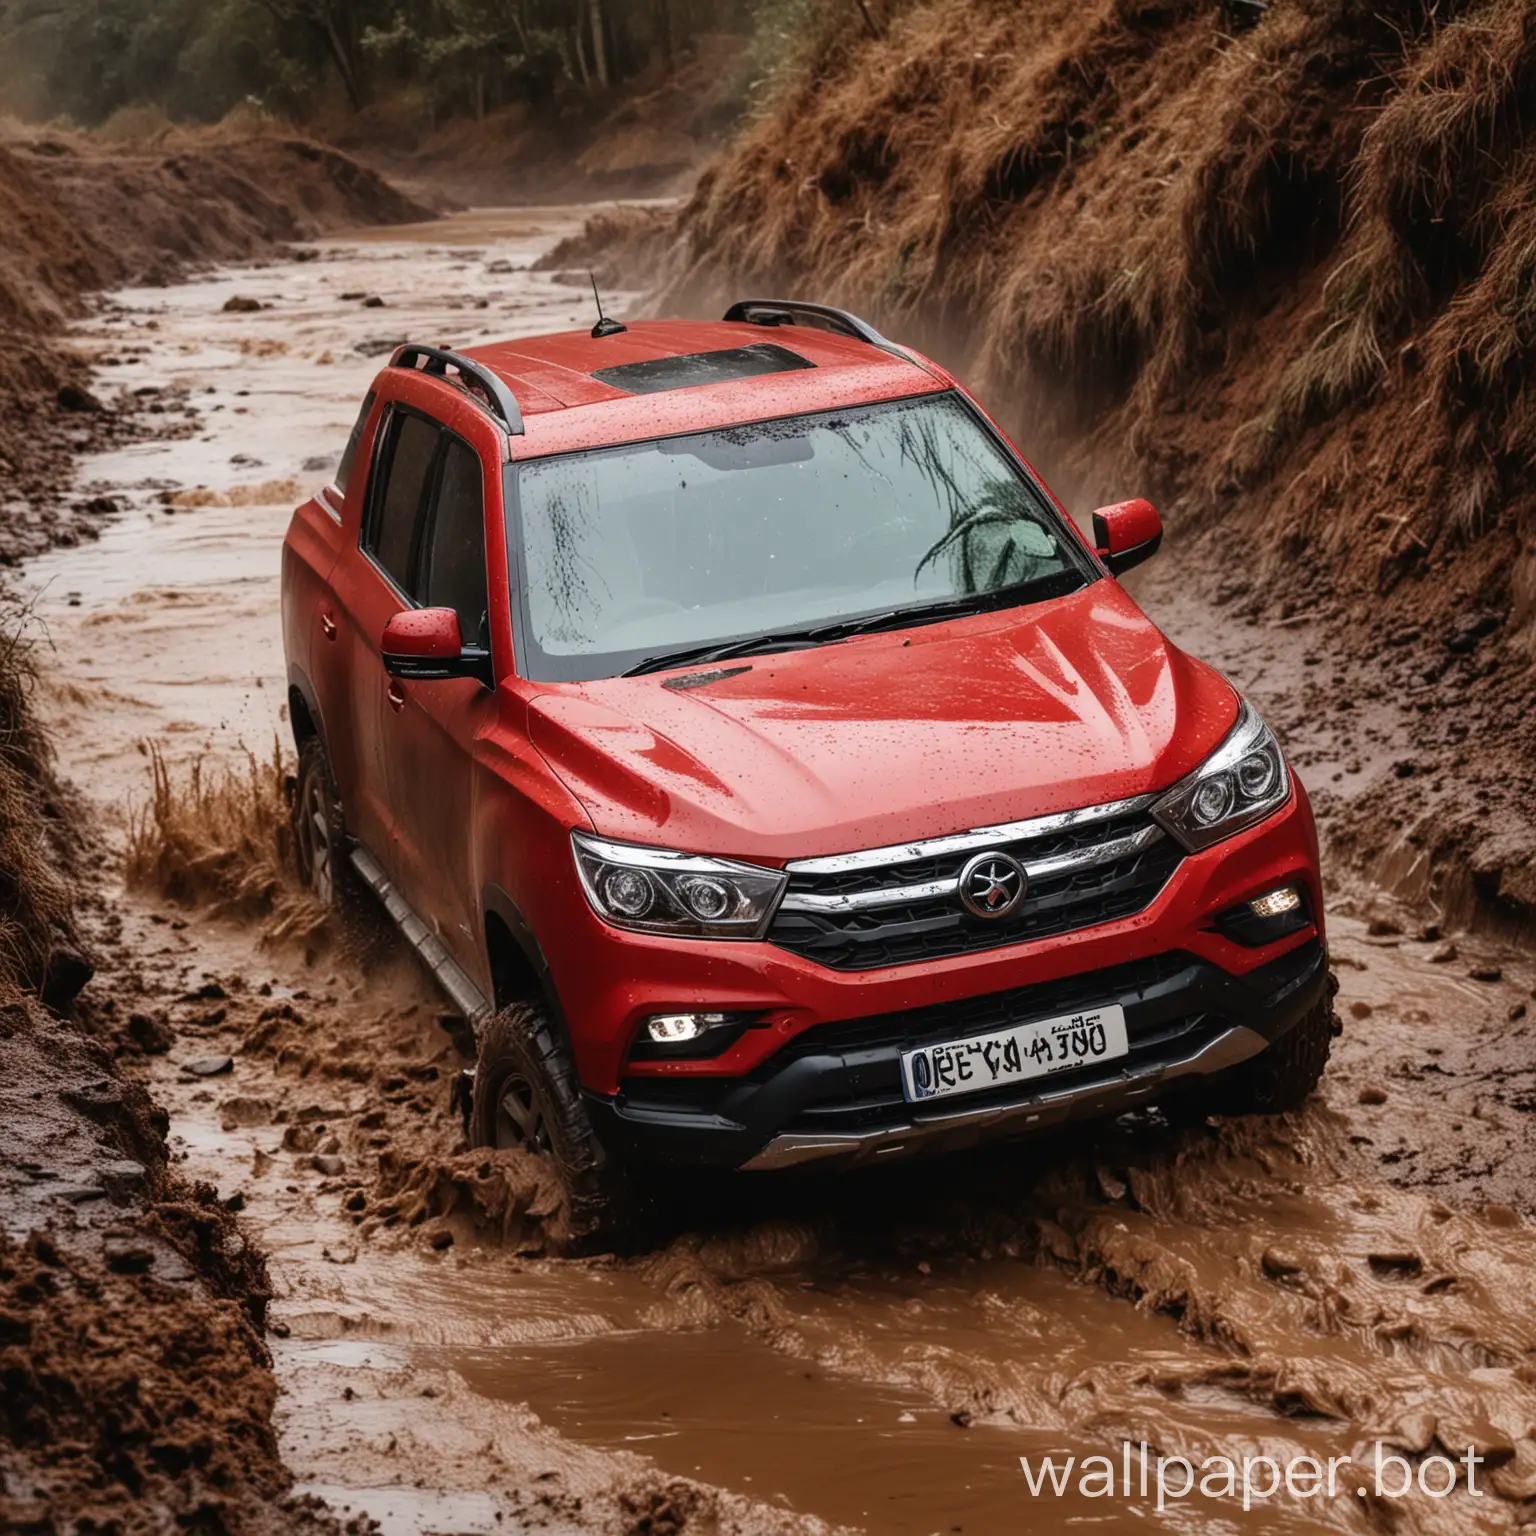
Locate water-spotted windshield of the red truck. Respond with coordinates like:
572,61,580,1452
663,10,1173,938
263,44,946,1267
508,395,1098,680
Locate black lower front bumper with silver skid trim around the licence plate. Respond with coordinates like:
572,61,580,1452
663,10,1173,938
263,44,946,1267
587,937,1327,1169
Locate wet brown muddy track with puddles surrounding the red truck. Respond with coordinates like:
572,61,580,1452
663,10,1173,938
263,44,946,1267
26,210,1536,1536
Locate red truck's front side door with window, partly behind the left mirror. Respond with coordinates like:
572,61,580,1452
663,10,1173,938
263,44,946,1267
384,432,495,965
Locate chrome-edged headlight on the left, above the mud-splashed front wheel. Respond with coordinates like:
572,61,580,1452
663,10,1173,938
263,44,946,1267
571,833,790,938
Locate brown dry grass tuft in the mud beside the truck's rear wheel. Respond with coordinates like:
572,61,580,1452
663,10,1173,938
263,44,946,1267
124,740,326,943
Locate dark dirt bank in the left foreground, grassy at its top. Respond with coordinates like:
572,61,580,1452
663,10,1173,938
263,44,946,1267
0,608,329,1531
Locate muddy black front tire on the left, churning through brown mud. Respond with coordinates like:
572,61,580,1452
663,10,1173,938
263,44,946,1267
470,1003,637,1255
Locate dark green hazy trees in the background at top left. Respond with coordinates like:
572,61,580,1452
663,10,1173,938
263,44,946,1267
0,0,786,126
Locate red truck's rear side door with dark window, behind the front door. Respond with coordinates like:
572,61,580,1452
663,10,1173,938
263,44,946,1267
332,404,442,882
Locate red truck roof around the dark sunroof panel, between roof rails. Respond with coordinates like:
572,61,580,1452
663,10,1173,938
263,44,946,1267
462,319,949,458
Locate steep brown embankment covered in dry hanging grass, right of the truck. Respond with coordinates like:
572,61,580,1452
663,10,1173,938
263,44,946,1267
610,0,1536,919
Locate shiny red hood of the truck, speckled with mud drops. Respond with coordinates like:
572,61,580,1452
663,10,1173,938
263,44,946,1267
530,581,1236,862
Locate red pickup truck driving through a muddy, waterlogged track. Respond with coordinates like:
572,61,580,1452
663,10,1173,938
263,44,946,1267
283,301,1336,1249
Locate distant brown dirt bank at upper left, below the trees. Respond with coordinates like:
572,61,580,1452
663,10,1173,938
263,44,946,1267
0,129,432,565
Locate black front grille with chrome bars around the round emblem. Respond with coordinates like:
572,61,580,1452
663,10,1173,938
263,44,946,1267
768,797,1183,971
